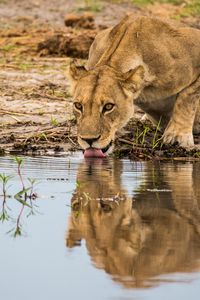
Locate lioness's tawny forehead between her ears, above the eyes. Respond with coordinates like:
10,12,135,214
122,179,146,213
74,72,124,103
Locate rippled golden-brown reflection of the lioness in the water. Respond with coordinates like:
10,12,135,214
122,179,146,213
66,160,200,287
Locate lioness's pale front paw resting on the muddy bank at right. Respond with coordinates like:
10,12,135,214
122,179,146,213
163,131,194,148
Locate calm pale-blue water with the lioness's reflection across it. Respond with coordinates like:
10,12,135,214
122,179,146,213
0,155,200,300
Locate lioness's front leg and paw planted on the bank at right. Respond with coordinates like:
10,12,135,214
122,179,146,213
163,78,200,148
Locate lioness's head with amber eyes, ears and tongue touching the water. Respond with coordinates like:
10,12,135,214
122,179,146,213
69,62,144,157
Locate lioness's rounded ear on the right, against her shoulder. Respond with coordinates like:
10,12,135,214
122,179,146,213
121,66,145,93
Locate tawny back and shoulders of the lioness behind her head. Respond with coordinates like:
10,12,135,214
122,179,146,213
87,15,200,94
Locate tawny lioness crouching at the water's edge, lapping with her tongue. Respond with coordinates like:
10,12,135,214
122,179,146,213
69,15,200,157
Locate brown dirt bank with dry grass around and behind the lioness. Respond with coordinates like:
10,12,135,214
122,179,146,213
0,0,200,159
